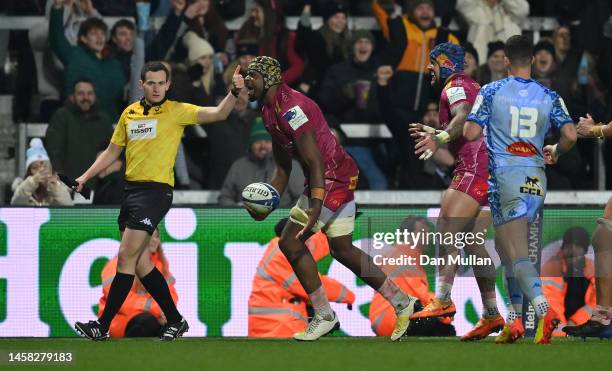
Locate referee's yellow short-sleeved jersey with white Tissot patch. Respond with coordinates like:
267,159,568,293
111,100,200,187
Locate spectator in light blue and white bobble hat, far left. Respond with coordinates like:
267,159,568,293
11,138,72,206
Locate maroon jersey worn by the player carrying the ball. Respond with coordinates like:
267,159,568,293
262,84,359,211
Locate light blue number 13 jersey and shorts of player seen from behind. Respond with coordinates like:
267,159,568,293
467,77,573,225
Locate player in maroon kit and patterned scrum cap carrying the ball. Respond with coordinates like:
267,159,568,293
245,56,416,341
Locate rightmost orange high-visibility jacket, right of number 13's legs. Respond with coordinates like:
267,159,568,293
541,251,596,328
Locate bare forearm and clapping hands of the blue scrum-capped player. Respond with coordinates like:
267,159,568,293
413,102,472,160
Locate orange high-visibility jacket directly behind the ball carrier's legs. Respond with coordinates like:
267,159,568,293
249,232,355,338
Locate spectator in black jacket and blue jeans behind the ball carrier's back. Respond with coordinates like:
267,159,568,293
319,31,388,190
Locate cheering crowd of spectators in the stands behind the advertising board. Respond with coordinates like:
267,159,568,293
0,0,612,205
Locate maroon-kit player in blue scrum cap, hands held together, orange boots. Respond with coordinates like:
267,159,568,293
410,43,505,341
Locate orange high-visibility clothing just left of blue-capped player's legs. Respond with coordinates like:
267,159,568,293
369,245,435,336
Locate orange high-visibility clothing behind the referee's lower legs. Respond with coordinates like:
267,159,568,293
98,254,178,338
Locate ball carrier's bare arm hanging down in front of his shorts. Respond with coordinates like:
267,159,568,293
296,131,325,239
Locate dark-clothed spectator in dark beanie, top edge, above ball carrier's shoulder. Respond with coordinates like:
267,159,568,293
297,0,351,98
